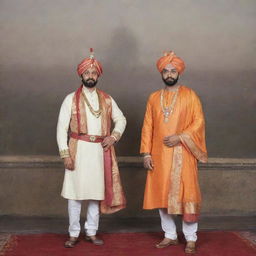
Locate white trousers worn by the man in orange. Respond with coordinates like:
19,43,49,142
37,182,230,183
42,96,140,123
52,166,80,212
159,209,198,241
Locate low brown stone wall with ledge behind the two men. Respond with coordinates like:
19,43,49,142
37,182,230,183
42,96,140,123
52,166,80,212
0,156,256,217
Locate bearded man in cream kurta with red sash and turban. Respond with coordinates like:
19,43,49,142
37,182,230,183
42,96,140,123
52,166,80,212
57,48,126,248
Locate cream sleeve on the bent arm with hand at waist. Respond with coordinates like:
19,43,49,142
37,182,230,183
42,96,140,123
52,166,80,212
111,98,126,140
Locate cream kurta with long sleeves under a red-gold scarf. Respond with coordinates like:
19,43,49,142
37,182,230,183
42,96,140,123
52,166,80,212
57,87,126,200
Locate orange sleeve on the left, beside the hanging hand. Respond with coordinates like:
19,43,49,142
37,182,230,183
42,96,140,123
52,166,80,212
140,95,154,154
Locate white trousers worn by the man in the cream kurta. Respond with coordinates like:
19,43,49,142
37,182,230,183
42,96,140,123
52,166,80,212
68,199,100,237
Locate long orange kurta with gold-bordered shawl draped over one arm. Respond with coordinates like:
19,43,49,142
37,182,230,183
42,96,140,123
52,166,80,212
140,86,207,221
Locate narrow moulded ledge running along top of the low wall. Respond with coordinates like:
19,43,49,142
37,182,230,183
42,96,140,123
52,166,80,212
0,155,256,171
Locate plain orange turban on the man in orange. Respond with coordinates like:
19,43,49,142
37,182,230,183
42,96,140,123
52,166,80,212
156,51,185,74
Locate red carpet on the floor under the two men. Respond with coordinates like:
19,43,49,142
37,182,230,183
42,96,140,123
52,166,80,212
2,231,256,256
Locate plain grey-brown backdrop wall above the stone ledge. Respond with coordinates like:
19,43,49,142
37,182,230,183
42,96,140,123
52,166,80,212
0,0,256,158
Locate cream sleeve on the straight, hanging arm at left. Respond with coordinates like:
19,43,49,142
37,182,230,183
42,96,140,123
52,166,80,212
57,94,73,158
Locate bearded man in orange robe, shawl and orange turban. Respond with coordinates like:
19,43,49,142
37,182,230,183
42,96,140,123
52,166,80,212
140,52,207,253
